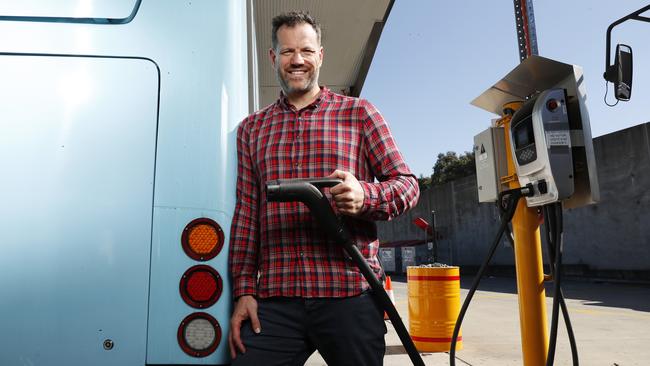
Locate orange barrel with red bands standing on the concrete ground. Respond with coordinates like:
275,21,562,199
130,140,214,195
406,267,463,352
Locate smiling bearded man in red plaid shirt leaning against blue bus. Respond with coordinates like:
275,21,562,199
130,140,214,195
228,12,419,365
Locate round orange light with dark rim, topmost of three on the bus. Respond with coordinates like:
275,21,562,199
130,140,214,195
181,217,224,261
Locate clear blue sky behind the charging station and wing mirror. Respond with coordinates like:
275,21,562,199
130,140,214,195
361,0,650,176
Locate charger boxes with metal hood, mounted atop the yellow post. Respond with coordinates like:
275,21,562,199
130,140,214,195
472,56,600,208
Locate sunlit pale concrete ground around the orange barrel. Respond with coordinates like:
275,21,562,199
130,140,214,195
306,277,650,366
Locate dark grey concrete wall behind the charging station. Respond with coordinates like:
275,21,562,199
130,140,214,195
378,123,650,280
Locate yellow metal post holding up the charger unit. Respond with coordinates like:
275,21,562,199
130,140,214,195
496,102,548,366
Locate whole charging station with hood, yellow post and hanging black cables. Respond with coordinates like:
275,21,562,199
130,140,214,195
456,55,600,366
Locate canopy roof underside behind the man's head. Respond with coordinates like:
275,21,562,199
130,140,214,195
249,0,394,109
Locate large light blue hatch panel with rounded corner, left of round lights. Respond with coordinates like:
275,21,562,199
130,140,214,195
0,54,159,366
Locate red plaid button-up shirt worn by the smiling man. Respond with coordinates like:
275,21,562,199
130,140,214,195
229,88,419,298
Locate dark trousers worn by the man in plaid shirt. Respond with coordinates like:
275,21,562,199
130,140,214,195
232,292,386,366
